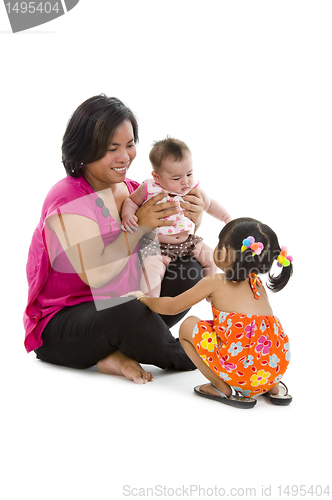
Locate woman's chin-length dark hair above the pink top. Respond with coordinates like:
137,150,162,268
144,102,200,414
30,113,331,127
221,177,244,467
62,94,138,177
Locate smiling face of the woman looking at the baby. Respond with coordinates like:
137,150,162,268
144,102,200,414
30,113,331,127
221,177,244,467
84,120,136,191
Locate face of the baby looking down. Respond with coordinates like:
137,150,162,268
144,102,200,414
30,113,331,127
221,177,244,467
152,153,195,196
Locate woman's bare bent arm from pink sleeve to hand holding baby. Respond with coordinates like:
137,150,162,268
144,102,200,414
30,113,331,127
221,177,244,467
48,194,179,288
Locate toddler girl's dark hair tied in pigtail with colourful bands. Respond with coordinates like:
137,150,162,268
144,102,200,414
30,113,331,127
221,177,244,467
218,217,293,292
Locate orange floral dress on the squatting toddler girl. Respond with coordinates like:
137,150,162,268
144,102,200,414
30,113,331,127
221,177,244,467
193,276,290,397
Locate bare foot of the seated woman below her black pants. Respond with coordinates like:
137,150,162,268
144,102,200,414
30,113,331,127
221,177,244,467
97,351,153,384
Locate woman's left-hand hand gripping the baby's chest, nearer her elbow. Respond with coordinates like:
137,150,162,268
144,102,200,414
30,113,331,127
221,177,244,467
135,193,181,229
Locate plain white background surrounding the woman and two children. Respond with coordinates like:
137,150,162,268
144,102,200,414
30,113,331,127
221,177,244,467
0,0,332,500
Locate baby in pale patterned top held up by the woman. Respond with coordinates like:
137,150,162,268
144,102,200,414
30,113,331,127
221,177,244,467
121,137,232,297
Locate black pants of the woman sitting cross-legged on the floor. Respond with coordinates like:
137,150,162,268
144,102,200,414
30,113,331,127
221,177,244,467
35,257,202,370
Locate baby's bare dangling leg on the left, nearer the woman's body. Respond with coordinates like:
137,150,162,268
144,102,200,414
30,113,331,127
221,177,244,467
140,255,171,297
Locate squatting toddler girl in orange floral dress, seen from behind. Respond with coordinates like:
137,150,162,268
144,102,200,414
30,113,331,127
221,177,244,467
128,218,293,408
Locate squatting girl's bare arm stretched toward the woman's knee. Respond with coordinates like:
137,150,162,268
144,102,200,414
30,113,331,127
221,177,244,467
134,274,220,316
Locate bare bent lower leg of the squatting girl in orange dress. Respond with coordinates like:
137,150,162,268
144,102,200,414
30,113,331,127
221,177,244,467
179,316,232,397
